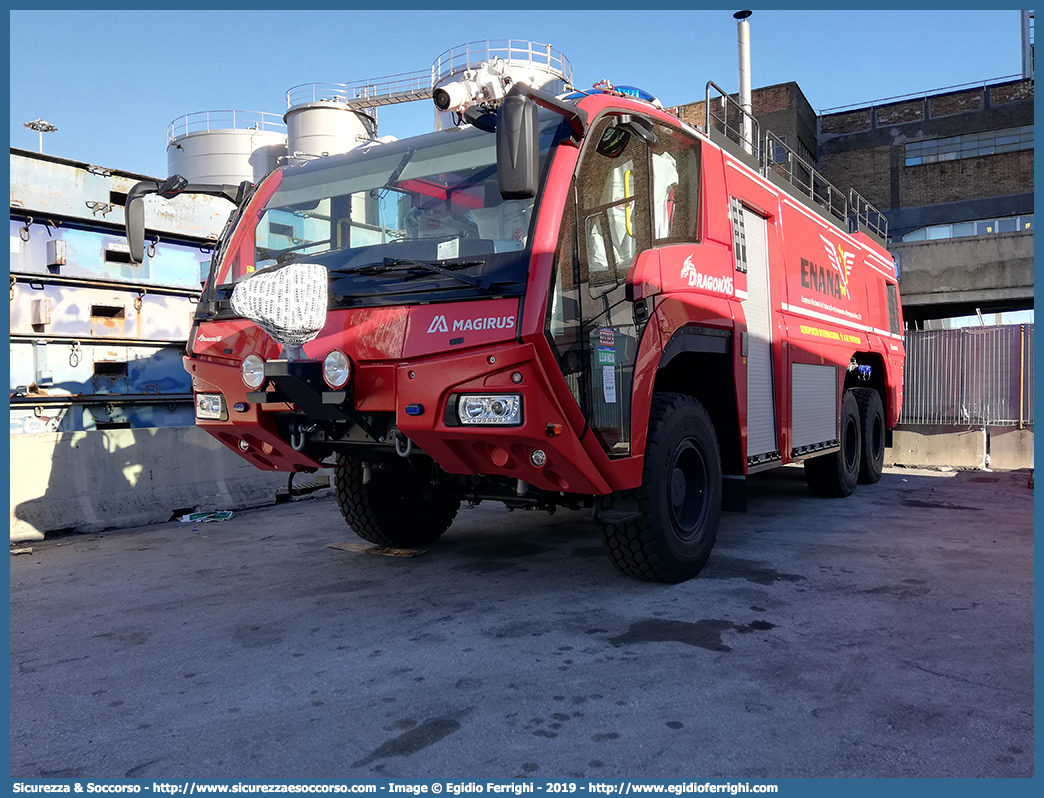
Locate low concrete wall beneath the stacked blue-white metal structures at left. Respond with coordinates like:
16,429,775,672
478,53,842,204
10,427,327,541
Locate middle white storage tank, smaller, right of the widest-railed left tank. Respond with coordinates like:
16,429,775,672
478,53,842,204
283,84,377,160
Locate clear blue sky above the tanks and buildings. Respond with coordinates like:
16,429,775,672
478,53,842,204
9,9,1021,177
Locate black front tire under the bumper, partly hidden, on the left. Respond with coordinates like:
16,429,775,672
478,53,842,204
335,454,460,548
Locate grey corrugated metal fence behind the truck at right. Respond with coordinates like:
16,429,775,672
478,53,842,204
899,324,1034,426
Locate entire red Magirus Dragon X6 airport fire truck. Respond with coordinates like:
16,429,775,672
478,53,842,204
126,76,904,583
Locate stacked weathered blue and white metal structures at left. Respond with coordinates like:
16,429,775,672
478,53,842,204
9,148,232,436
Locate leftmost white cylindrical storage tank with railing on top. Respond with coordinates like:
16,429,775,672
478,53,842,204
167,111,286,185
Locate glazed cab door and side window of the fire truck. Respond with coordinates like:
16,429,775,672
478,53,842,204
547,115,698,456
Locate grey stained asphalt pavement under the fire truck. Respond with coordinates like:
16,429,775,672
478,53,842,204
10,467,1034,779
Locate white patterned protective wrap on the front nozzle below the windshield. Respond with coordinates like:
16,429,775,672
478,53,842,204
232,263,329,346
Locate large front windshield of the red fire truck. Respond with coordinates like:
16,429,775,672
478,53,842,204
215,116,562,292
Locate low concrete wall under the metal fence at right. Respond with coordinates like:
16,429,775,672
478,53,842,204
884,424,1034,470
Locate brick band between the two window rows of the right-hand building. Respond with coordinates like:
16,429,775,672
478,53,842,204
897,149,1034,208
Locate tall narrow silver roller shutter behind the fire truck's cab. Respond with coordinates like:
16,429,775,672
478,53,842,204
732,198,779,465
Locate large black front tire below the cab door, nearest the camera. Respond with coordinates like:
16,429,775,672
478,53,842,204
601,394,721,583
